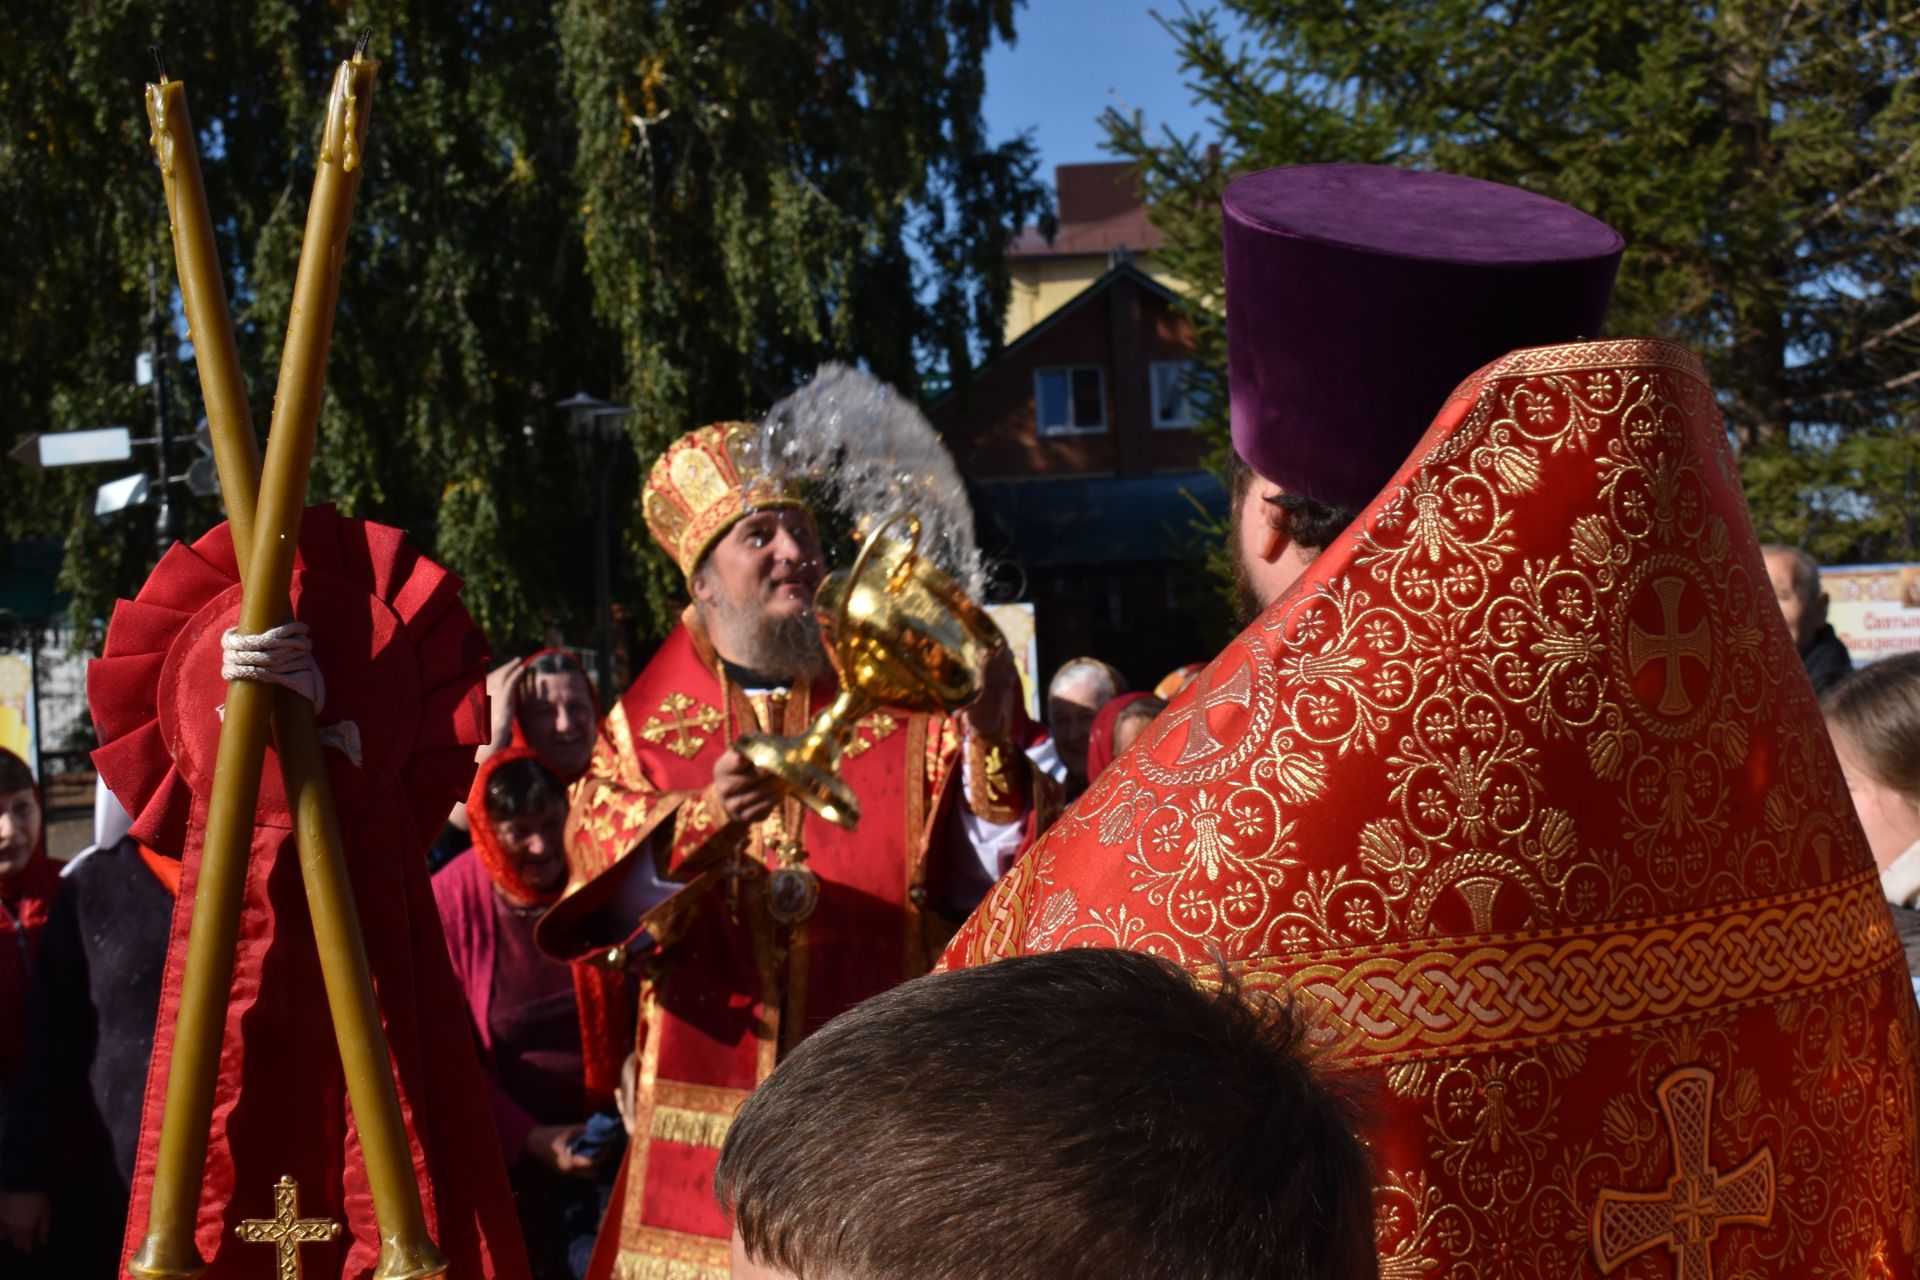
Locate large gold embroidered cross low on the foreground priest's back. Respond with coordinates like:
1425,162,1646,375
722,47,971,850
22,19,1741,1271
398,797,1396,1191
1592,1067,1774,1280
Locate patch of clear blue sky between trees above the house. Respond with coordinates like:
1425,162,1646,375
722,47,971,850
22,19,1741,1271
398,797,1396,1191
985,0,1236,182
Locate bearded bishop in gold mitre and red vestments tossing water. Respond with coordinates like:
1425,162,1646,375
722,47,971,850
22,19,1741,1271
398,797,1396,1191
540,422,1033,1280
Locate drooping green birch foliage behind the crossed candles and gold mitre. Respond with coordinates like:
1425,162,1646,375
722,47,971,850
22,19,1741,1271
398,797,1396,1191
0,0,1043,647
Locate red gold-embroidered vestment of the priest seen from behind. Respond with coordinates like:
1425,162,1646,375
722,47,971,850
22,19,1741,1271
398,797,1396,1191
943,342,1920,1280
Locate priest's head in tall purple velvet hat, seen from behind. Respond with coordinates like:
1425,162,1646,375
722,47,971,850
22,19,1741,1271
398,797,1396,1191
1221,165,1624,624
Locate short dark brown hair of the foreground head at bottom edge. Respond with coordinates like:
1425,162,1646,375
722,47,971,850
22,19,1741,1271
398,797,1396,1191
714,950,1379,1280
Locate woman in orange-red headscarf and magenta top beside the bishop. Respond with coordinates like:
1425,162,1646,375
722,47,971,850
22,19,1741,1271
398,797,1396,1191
434,747,634,1276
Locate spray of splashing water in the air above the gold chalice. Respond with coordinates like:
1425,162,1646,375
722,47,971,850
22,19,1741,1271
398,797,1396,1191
745,365,987,599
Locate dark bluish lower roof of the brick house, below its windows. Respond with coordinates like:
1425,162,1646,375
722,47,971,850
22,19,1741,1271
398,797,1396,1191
977,472,1227,568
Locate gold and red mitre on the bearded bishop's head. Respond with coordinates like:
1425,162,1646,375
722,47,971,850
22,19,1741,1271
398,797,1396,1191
641,422,806,574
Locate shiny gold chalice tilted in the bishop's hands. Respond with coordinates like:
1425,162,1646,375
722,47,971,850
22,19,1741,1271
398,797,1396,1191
739,512,1006,829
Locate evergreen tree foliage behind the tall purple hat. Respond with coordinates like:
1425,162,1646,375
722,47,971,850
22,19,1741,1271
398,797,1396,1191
1108,0,1920,558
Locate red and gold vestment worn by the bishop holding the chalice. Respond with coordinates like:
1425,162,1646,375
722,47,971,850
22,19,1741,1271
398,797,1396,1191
541,610,1013,1280
